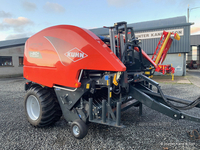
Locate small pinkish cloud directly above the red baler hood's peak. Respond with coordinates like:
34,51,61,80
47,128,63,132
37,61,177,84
43,2,65,13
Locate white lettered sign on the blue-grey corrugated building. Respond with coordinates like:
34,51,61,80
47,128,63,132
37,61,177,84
135,28,184,39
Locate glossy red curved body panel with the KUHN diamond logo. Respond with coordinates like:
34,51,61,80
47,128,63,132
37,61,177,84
24,25,126,88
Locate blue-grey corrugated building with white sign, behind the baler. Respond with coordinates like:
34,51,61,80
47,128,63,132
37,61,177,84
91,16,192,76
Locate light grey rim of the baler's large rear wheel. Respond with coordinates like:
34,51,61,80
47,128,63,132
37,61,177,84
26,95,40,120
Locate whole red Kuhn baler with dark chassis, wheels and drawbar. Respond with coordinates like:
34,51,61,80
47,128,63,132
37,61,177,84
24,22,200,139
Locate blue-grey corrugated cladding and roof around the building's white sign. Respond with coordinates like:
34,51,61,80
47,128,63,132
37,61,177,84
91,16,191,55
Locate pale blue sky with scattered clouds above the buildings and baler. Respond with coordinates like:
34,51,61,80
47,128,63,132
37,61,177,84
0,0,200,41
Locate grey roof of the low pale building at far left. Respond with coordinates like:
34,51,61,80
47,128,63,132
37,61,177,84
0,38,28,48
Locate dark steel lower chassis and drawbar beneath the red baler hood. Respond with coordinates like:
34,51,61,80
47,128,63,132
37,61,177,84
25,71,200,139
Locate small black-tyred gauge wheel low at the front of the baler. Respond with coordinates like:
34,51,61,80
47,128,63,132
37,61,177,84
71,119,88,139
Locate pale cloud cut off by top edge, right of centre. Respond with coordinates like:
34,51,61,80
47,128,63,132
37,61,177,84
107,0,140,7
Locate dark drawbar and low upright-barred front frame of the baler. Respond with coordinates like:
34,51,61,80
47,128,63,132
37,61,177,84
89,74,200,127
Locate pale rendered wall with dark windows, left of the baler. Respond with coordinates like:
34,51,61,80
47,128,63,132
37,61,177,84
0,46,24,77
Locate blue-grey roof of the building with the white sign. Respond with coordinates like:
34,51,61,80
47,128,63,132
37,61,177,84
90,16,190,35
